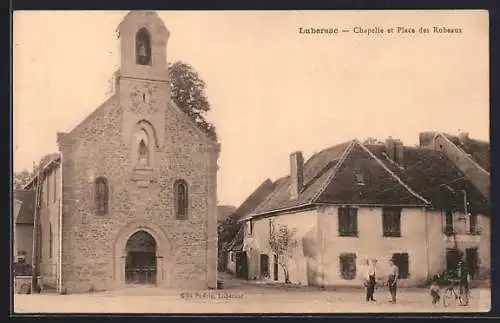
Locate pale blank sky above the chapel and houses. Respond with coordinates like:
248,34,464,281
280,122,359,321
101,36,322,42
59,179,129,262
13,11,489,206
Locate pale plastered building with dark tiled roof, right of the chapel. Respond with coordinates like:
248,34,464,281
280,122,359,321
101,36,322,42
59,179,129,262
238,133,491,286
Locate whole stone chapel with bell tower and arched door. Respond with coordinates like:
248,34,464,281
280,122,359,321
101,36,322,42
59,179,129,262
19,11,220,293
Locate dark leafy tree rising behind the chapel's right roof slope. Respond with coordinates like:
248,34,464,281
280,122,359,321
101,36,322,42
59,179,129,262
168,61,217,139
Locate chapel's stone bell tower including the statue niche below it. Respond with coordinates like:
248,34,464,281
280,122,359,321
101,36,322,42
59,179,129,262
117,11,170,180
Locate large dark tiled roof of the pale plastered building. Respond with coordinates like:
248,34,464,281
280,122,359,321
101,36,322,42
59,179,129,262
248,141,490,219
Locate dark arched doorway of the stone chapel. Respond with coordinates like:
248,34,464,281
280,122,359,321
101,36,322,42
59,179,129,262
125,230,157,284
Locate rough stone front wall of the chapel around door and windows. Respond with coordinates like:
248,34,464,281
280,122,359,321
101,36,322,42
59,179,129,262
55,92,219,293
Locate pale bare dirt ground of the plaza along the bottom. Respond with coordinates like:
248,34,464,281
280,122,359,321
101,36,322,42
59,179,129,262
14,276,491,313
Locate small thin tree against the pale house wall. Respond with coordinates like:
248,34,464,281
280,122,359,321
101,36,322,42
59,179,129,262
269,225,298,284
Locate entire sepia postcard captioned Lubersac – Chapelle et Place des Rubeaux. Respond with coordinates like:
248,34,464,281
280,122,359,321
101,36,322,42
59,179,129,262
11,10,491,314
